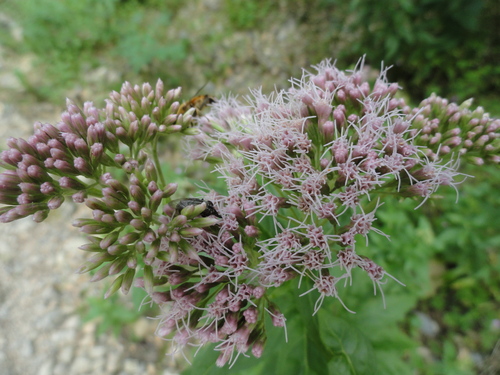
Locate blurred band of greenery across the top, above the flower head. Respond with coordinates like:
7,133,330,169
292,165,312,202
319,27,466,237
4,0,500,114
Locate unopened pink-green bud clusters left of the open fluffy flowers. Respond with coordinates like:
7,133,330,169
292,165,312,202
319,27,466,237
0,81,234,312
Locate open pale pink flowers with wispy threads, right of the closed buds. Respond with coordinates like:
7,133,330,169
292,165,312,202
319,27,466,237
179,61,472,365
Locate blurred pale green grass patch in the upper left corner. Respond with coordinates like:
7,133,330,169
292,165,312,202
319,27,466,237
1,0,188,101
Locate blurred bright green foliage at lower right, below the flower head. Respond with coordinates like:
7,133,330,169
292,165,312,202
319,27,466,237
360,166,500,374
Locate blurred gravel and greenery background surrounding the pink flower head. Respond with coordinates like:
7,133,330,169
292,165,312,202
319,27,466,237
0,0,500,375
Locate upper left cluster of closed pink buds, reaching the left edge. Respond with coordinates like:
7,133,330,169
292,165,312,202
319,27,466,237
0,81,184,223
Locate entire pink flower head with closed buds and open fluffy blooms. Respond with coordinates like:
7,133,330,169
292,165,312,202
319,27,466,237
0,61,500,366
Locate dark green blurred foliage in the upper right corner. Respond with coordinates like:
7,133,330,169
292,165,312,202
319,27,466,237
340,0,500,113
